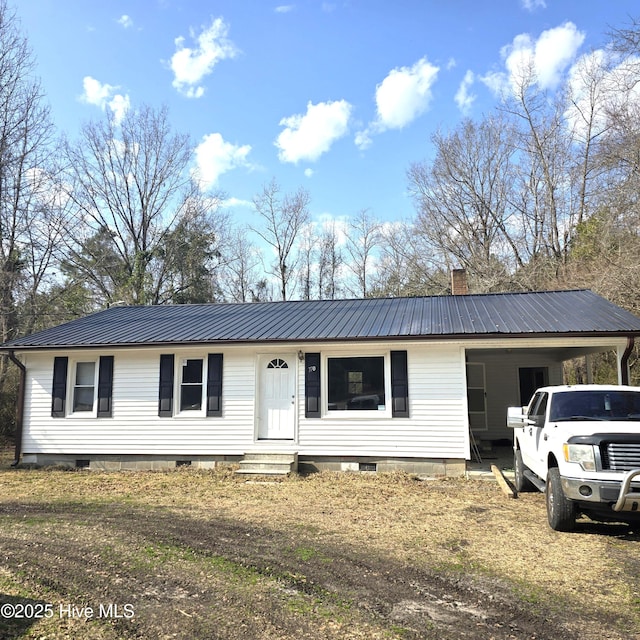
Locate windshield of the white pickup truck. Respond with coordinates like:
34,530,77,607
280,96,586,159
549,391,640,422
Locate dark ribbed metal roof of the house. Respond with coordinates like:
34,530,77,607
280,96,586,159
2,290,640,350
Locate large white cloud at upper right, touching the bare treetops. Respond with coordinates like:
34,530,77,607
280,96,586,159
482,22,585,93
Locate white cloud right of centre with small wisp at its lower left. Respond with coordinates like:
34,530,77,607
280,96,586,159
355,58,440,149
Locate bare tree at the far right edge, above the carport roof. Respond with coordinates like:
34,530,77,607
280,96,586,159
569,22,640,313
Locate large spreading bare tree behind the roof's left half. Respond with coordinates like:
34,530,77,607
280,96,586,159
65,107,221,304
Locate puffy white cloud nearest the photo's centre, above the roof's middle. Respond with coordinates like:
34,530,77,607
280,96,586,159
275,100,352,163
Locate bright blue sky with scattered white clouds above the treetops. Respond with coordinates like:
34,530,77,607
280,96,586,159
14,0,640,230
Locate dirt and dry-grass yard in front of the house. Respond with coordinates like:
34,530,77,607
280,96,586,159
0,450,640,640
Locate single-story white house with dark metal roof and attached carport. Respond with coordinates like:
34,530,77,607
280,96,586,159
0,290,640,475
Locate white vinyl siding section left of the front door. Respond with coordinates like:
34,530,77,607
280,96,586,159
23,349,255,455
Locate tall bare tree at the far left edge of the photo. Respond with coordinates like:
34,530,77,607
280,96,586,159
0,0,60,341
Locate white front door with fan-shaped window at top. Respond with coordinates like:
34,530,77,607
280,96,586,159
258,354,296,440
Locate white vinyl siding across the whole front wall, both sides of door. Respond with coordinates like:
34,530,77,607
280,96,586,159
23,345,467,458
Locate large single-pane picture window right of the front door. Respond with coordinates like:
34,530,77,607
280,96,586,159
327,356,385,411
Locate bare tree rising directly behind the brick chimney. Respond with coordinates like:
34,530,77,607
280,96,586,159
409,117,523,290
